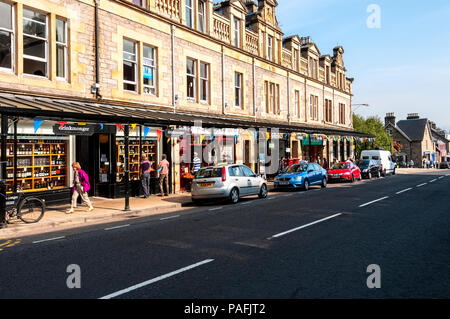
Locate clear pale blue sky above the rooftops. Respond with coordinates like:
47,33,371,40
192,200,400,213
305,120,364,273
276,0,450,130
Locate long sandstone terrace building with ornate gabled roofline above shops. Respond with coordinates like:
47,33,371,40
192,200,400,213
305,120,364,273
0,0,370,200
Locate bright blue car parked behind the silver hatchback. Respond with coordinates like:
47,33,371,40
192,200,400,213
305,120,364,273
275,162,328,191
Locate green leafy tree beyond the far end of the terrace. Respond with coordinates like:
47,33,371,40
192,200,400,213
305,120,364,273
353,114,392,158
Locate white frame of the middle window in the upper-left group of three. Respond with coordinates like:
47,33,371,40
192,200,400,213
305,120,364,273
22,7,50,79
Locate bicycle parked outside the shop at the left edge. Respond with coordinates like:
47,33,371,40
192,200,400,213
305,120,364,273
1,193,45,224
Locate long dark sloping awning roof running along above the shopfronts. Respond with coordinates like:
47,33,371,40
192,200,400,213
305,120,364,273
0,92,374,138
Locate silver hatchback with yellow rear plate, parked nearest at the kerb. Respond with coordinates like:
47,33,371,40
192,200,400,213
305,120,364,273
191,164,267,204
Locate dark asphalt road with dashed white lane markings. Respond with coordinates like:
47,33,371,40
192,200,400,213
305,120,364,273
0,171,450,299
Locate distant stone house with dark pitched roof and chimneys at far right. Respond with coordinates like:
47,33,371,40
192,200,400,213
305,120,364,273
385,113,450,167
